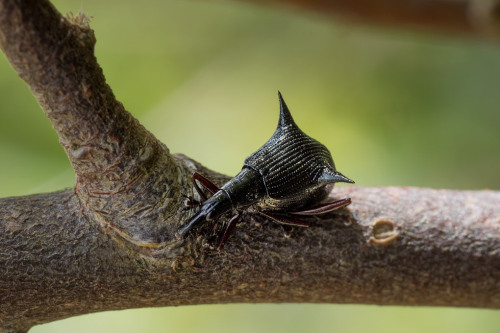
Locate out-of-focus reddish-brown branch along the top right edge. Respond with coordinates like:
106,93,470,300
250,0,500,39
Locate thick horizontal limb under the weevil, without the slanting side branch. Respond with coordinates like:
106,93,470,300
0,187,500,331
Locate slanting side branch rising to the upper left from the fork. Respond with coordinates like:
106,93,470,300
0,0,185,242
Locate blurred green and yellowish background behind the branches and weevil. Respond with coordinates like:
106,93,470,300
0,0,500,333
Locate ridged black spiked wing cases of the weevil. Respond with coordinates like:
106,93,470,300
245,92,354,199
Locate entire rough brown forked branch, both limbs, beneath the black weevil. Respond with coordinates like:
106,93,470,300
0,0,500,332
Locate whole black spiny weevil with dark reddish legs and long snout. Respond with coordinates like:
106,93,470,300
177,92,354,250
